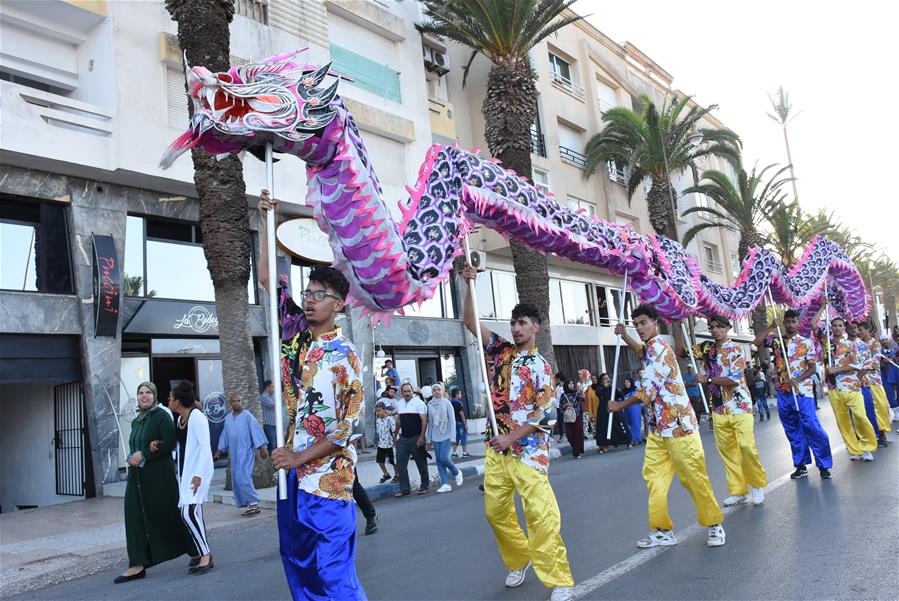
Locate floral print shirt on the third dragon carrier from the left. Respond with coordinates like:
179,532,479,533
634,336,696,438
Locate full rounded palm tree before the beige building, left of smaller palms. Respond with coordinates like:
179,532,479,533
584,96,740,240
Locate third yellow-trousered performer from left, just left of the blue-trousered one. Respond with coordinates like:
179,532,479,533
674,315,768,507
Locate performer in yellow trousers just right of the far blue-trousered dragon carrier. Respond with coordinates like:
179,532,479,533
827,317,877,461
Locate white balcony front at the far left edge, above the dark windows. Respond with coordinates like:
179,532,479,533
0,81,114,169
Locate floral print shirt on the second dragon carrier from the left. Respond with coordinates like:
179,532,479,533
485,333,556,474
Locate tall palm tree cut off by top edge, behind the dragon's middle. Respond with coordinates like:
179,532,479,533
416,0,581,366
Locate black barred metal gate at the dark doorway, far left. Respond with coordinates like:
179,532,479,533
53,382,85,497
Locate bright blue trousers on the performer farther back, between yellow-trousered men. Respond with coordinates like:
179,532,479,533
777,390,833,469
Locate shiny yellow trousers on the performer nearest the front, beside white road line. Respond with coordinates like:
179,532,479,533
484,447,574,588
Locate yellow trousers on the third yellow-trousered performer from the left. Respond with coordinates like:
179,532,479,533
712,413,768,496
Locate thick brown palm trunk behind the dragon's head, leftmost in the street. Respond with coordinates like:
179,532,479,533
166,0,272,486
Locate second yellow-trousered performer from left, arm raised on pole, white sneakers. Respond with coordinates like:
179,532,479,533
608,305,725,549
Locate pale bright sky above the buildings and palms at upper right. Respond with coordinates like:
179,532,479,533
573,0,899,262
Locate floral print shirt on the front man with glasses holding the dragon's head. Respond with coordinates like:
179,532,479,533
279,288,363,501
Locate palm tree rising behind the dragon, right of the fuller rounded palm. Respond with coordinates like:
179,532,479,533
683,165,790,334
